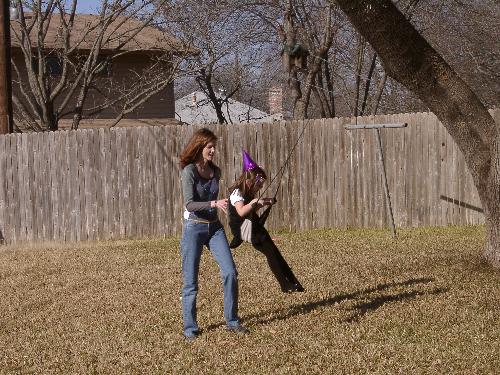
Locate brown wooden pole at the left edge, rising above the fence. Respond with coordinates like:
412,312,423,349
0,0,13,134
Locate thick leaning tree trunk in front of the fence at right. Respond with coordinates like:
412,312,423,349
336,0,500,267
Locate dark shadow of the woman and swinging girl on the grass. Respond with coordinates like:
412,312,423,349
207,278,447,331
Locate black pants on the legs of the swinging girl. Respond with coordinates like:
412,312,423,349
252,222,304,292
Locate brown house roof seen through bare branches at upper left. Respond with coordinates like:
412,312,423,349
11,13,189,53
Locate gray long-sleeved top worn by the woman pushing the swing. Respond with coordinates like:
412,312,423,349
181,164,220,221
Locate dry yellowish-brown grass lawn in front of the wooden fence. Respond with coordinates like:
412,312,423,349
0,227,500,375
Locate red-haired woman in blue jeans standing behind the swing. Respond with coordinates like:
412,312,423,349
180,128,248,341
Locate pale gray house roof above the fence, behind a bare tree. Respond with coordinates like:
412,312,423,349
175,91,282,124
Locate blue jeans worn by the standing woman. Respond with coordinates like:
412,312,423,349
181,220,240,336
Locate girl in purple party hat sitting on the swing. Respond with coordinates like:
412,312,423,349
228,151,304,293
